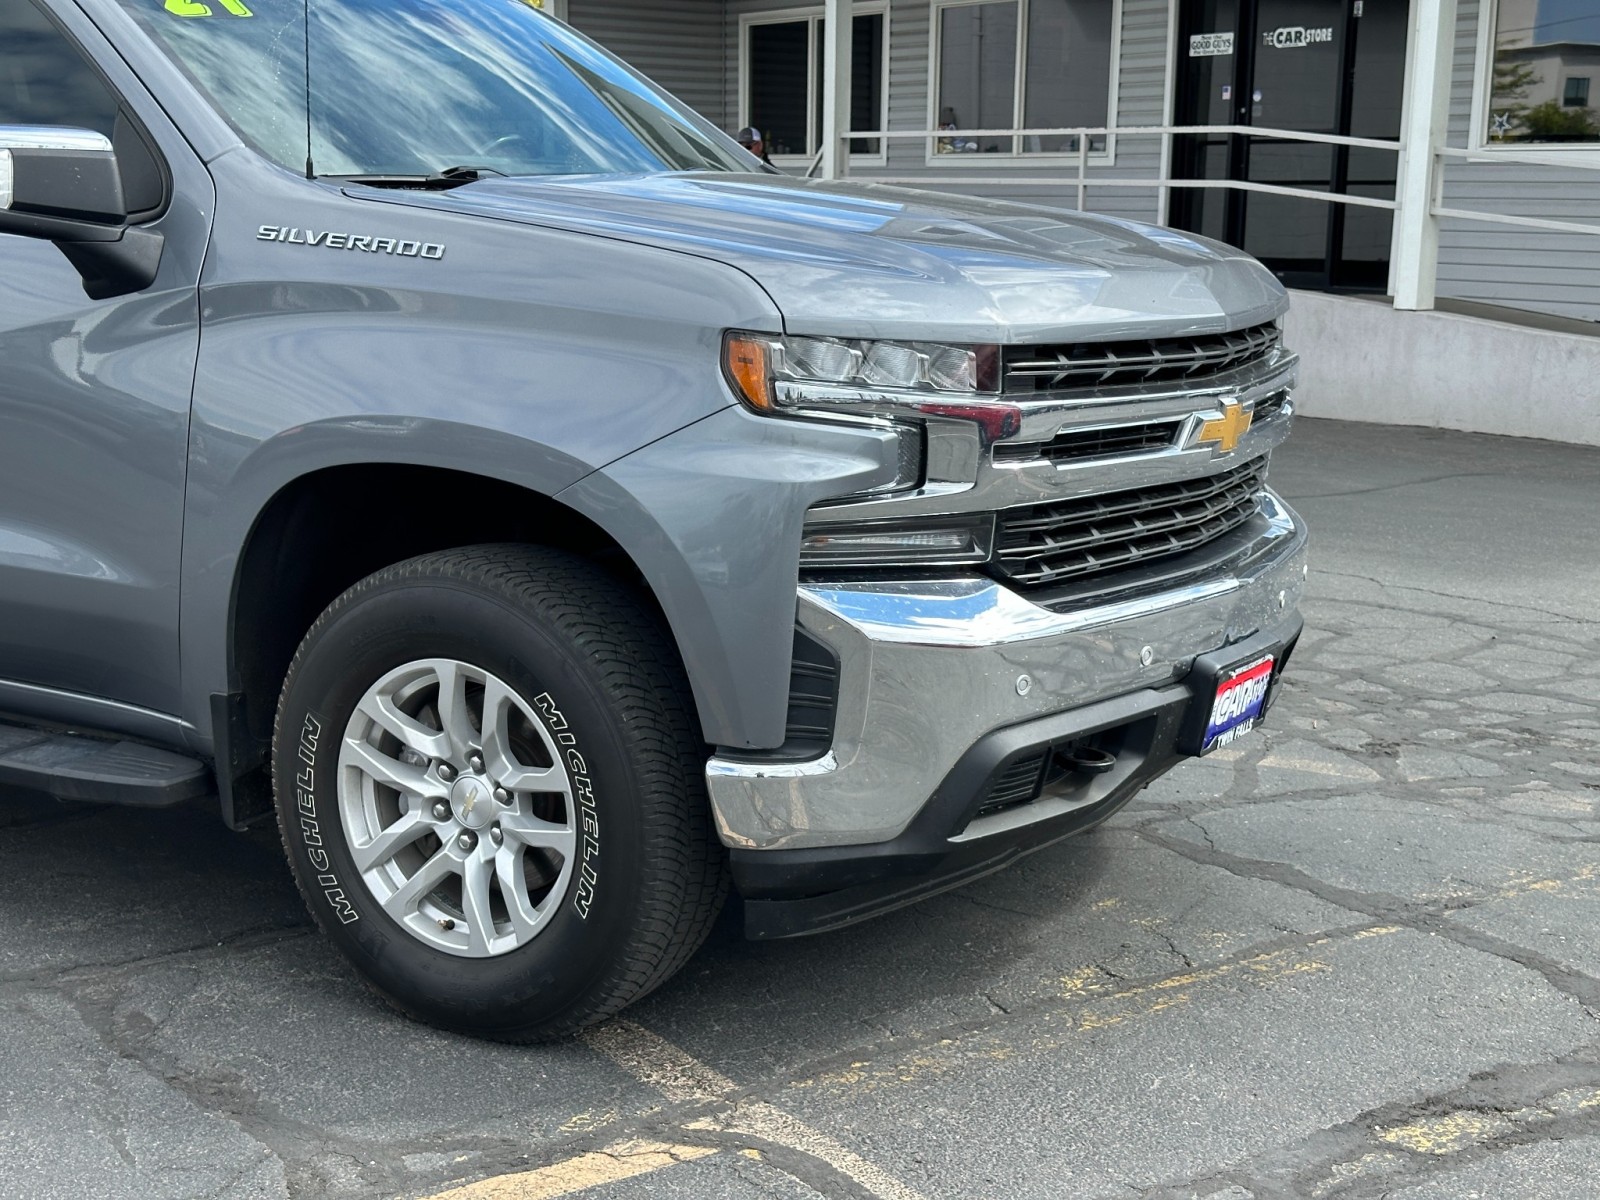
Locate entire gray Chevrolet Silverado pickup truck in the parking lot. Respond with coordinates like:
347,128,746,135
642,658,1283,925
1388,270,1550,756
0,0,1306,1040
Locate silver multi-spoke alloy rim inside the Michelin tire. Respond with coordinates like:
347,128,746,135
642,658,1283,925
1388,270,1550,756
339,659,578,957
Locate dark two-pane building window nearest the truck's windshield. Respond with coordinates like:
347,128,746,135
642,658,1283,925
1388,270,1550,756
739,5,888,158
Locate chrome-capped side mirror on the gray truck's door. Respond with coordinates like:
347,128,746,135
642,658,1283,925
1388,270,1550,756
0,125,162,299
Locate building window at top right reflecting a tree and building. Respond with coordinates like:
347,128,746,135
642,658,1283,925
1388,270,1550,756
1483,0,1600,147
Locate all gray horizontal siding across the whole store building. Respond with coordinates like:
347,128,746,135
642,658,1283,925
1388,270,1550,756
568,0,1600,320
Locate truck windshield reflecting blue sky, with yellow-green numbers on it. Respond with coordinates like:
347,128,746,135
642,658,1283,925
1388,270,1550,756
122,0,758,178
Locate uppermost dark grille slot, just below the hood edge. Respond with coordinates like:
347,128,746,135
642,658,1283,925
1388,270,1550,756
1002,322,1282,392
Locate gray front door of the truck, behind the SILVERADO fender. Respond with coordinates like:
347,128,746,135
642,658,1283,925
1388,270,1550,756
0,0,211,712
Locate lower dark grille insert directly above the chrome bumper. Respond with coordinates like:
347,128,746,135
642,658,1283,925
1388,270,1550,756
994,458,1267,586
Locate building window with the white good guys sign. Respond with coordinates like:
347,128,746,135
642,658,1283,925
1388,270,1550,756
934,0,1117,154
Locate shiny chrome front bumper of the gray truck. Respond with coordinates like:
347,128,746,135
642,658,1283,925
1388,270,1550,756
706,493,1306,851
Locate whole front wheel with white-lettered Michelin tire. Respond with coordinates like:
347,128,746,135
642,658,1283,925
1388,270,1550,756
274,546,726,1042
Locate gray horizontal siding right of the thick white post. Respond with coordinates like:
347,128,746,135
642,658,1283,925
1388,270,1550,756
1438,0,1600,320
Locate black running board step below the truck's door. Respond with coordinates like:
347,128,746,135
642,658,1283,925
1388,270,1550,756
0,725,211,808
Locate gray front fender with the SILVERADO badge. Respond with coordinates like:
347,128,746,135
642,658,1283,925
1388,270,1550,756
181,149,781,752
